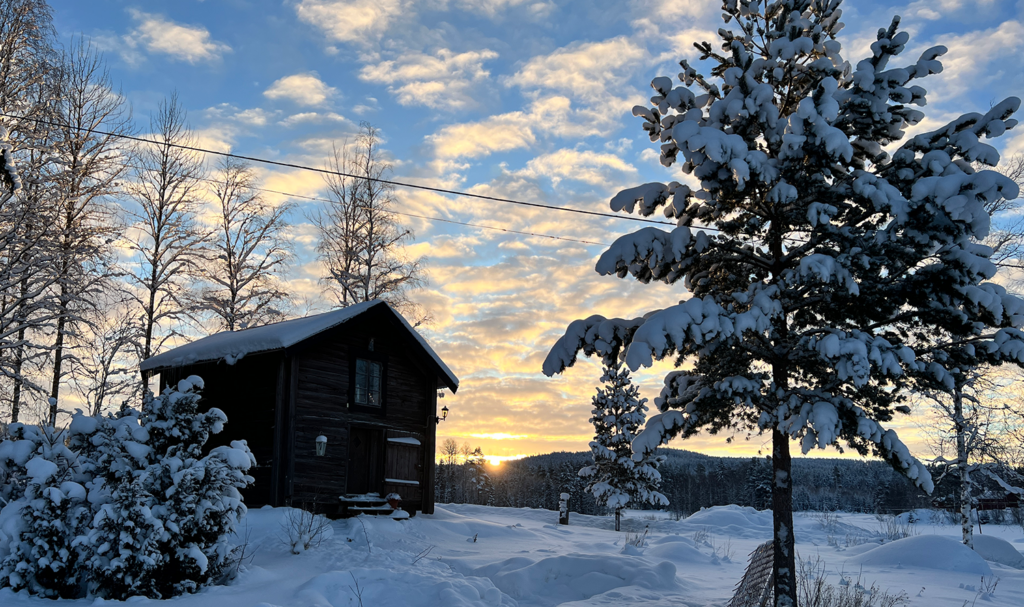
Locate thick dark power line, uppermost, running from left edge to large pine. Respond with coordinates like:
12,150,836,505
6,113,679,229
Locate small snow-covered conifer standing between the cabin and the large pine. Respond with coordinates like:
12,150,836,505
580,362,669,520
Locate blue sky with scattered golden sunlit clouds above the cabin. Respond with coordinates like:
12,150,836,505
50,0,1024,460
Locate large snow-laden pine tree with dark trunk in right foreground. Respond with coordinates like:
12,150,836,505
544,0,1024,606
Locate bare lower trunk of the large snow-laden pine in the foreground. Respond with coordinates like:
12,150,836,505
771,428,797,607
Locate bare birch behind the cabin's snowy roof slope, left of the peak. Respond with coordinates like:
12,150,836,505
202,153,291,331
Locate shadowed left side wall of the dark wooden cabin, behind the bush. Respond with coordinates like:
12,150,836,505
151,352,282,508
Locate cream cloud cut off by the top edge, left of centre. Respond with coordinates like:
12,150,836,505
295,0,409,44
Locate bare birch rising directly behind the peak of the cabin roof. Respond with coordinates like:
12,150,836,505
310,123,423,309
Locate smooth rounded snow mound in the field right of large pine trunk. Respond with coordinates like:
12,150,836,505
847,535,992,577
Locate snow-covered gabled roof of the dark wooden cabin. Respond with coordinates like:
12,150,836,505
140,300,459,388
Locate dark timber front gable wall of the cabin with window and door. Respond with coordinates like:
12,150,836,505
291,310,436,512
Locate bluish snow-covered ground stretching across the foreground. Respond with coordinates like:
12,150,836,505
0,505,1024,607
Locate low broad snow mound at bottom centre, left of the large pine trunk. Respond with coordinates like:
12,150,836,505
445,554,682,606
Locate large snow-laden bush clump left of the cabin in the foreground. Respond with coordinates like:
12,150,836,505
0,377,254,600
